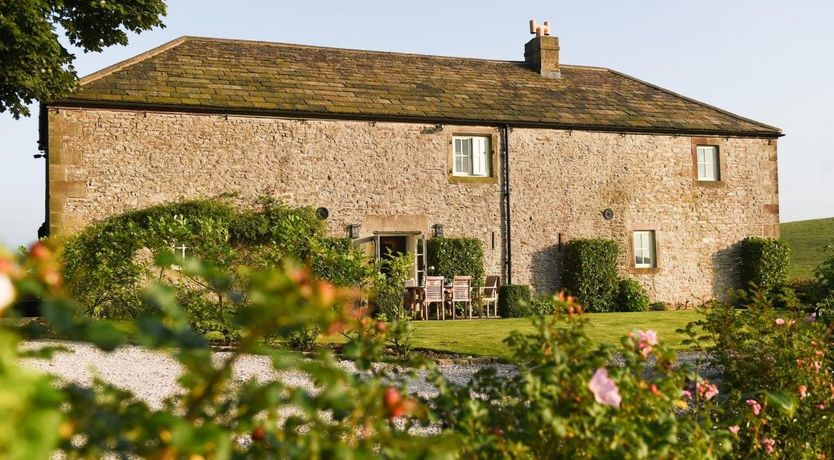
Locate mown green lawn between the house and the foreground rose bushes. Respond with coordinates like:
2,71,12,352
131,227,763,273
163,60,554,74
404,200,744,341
326,310,700,358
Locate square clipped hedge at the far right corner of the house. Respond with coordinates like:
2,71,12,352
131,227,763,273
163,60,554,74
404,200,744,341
741,237,791,292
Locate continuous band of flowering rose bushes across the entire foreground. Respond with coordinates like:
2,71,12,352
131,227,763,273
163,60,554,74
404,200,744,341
0,243,834,459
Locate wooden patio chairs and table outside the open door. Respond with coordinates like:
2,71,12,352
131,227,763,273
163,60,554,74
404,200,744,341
405,276,500,320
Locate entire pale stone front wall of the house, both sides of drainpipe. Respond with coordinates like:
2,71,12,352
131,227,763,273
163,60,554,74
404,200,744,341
49,108,779,302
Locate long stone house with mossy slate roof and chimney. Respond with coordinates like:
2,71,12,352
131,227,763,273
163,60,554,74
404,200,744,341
41,31,782,302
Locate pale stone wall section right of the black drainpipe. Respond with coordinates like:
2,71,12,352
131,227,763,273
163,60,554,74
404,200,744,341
509,129,779,303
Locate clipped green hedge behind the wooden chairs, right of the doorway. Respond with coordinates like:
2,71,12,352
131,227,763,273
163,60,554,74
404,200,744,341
426,237,484,286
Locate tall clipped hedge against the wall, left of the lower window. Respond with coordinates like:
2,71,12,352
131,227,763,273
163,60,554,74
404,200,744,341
562,239,619,312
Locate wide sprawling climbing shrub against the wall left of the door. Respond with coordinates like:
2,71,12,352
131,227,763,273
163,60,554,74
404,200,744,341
62,199,373,328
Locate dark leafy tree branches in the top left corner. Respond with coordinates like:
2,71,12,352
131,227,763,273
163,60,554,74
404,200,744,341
0,0,165,118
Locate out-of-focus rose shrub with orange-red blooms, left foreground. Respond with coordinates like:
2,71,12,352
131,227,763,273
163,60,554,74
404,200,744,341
0,243,448,459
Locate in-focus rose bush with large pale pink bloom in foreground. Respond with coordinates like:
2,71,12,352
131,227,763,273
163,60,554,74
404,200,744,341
432,294,731,459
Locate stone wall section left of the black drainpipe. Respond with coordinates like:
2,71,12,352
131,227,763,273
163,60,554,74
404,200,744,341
49,108,501,270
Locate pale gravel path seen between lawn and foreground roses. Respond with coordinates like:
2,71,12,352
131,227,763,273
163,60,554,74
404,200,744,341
21,341,719,408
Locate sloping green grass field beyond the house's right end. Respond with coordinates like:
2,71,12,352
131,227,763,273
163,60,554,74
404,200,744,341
780,217,834,278
